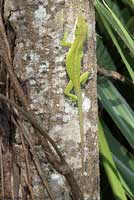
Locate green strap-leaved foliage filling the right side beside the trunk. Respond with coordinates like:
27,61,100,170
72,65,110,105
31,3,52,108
94,0,134,200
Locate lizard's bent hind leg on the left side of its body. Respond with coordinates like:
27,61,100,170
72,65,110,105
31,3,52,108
64,80,77,101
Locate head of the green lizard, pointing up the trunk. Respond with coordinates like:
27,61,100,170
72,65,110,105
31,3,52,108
75,15,88,39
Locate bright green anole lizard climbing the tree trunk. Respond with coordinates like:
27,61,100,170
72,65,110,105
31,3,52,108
61,16,89,173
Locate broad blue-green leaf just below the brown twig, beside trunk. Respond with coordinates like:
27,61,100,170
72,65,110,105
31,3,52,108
98,80,134,148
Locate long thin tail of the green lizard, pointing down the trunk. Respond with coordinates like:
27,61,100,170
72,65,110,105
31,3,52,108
77,91,84,174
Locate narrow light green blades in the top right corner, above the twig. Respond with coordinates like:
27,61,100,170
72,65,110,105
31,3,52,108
95,0,134,80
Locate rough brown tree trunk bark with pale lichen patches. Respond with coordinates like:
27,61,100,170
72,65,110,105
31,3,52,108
0,0,99,200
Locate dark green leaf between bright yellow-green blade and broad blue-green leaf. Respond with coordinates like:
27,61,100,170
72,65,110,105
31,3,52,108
101,121,134,199
